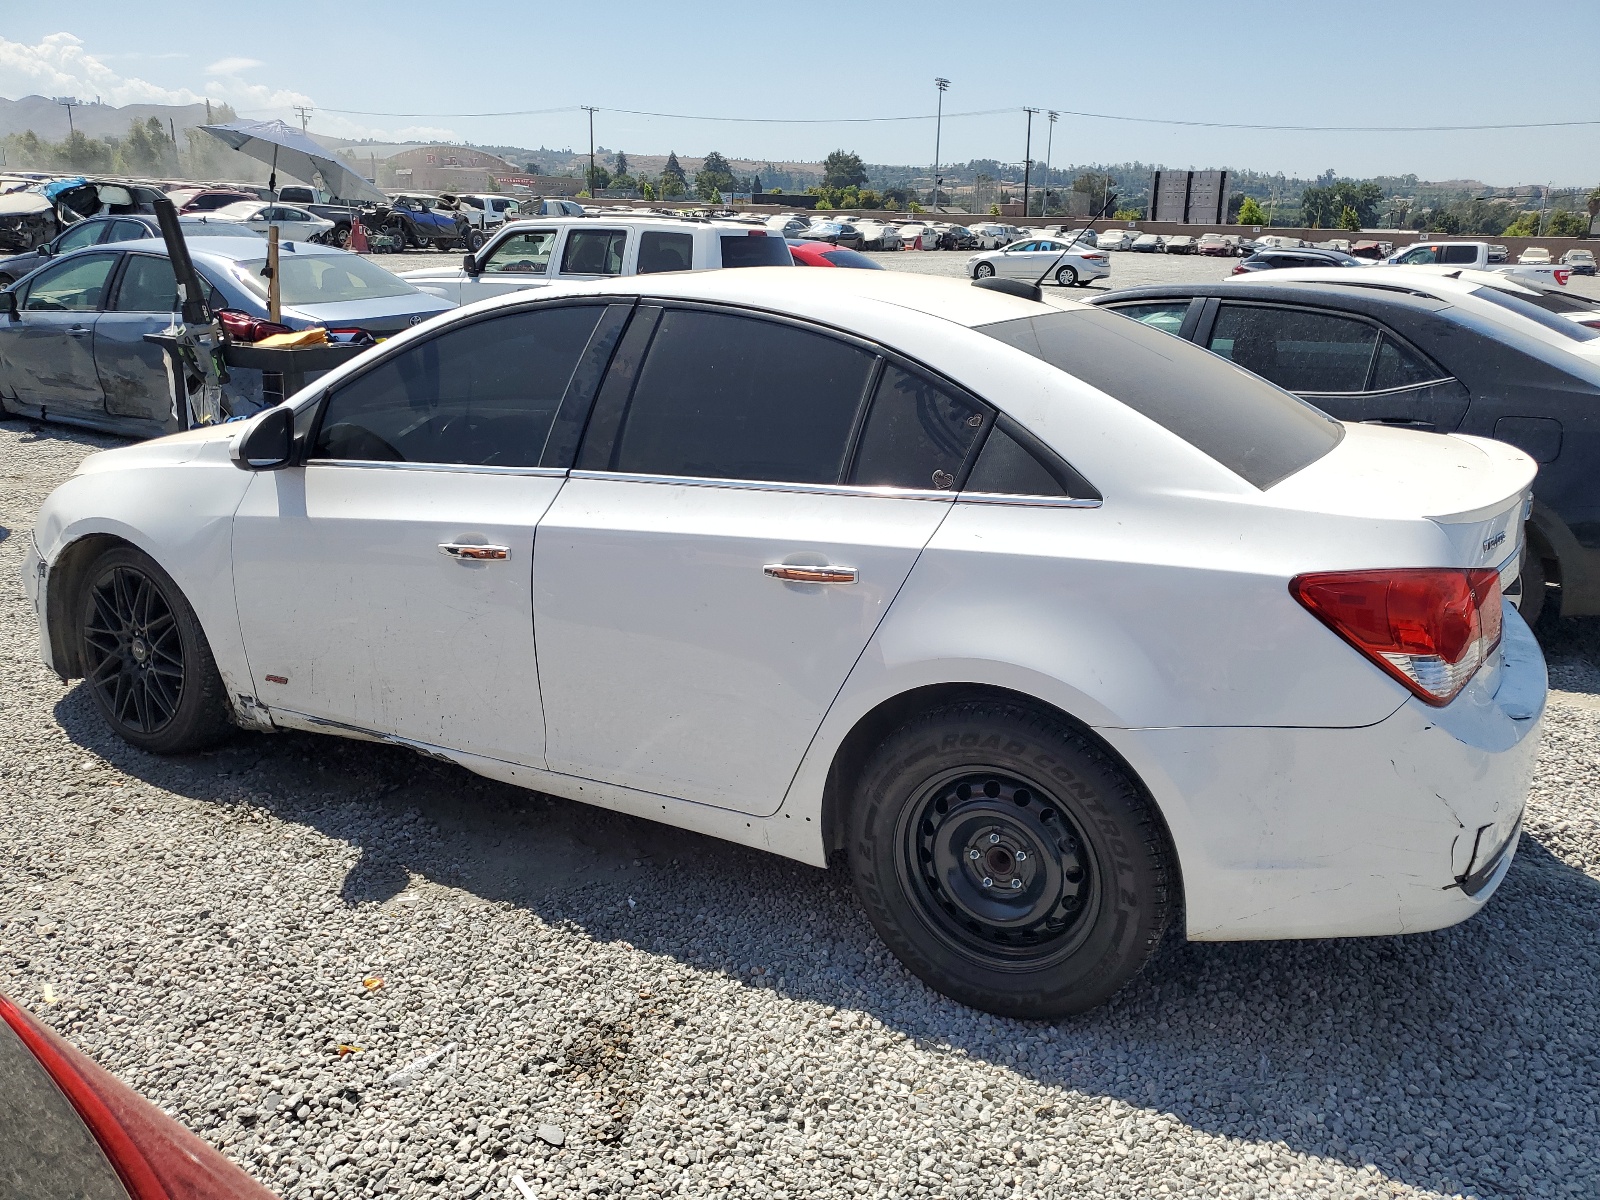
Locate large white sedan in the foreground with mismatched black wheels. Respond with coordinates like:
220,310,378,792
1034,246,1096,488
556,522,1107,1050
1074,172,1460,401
22,269,1546,1018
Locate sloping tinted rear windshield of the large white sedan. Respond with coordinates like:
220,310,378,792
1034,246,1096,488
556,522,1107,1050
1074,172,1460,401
978,309,1344,490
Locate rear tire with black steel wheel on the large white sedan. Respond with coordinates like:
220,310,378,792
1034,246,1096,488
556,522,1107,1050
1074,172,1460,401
846,701,1178,1021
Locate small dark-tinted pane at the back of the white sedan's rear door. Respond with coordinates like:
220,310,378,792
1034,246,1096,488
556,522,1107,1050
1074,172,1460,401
851,371,989,491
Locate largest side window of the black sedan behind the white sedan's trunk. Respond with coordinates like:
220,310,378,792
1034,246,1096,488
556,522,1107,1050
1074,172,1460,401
1210,304,1378,392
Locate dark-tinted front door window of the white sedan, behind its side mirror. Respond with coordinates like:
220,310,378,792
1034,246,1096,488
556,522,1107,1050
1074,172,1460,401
312,304,603,467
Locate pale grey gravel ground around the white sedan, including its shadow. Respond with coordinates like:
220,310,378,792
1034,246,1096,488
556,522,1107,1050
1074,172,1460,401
0,401,1600,1200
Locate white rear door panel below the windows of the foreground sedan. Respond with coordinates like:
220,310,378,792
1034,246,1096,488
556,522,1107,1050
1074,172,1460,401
534,472,949,814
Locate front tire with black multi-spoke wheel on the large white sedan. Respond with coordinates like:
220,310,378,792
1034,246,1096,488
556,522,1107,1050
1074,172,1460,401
75,546,230,754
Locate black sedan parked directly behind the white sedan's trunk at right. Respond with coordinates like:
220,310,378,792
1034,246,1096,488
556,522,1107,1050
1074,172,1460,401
1091,276,1600,622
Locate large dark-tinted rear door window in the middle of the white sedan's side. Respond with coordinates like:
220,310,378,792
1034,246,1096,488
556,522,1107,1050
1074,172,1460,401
610,309,874,483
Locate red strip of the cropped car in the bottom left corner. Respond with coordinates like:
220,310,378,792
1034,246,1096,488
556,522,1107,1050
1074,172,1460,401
0,997,275,1200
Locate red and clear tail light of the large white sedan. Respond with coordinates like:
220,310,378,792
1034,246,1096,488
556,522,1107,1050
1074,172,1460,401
1290,568,1501,706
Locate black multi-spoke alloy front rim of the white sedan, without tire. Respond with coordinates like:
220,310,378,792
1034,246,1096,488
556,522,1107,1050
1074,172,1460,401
83,566,184,734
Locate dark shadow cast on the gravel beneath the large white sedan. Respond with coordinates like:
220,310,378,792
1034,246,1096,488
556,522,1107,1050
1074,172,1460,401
56,686,1600,1197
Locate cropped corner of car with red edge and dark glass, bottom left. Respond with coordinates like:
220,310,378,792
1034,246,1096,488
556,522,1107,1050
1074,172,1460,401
0,995,277,1200
